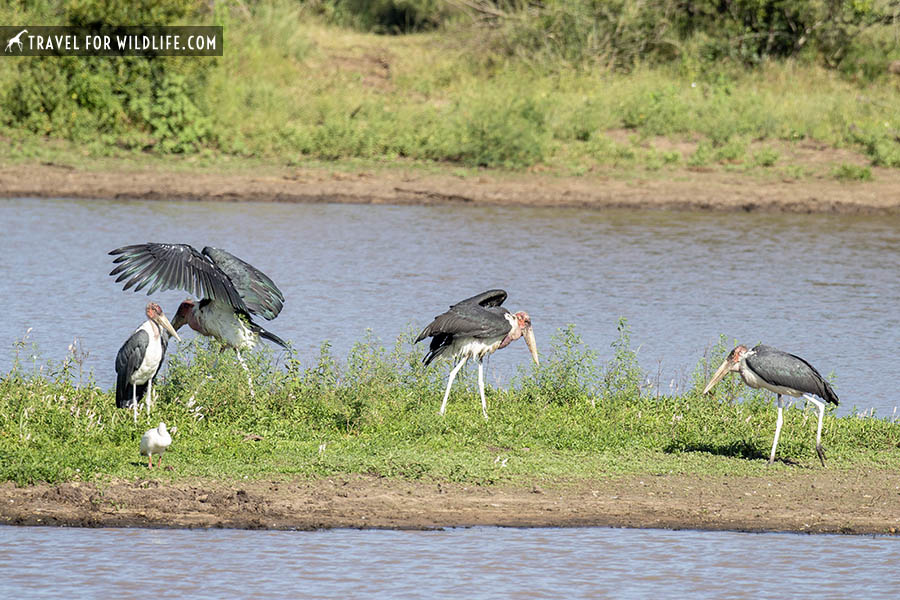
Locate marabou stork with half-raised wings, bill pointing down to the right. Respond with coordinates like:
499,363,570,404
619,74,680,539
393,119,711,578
416,290,540,419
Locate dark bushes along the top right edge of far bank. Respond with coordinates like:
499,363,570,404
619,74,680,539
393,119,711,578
468,0,898,70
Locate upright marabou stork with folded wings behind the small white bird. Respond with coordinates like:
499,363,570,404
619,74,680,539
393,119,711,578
116,302,181,423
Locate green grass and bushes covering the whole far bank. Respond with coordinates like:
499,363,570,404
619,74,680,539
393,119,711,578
0,0,900,180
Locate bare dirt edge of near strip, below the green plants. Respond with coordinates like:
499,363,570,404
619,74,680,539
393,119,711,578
0,468,900,534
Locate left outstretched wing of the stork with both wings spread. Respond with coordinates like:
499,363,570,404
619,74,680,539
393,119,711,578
109,242,250,312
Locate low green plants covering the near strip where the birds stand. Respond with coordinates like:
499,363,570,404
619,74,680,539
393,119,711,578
0,323,900,484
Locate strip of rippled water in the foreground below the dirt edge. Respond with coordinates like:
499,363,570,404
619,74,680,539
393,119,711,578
0,527,900,600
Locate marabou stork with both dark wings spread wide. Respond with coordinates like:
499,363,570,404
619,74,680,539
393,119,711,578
110,243,287,396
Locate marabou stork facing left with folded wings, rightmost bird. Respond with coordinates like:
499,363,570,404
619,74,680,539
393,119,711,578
703,344,838,467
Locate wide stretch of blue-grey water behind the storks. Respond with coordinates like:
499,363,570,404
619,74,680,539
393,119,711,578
0,199,900,416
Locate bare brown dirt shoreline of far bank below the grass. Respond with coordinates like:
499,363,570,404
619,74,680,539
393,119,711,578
0,163,900,214
